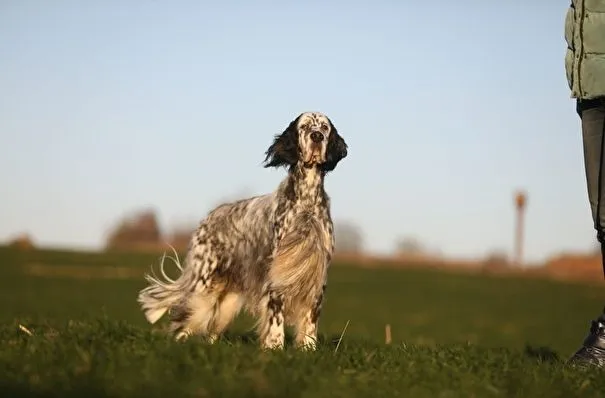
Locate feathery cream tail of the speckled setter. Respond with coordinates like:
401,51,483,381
137,248,186,324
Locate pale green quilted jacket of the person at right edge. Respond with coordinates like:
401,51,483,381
565,0,605,99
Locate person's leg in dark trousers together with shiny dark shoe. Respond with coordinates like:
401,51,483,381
570,98,605,366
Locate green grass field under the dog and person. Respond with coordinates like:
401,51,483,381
0,248,605,397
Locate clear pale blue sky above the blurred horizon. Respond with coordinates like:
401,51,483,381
0,0,594,261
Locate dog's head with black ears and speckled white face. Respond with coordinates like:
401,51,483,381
265,112,347,172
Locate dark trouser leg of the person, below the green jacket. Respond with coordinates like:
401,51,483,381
577,99,605,276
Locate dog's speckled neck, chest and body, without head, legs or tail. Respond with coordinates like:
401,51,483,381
194,168,334,302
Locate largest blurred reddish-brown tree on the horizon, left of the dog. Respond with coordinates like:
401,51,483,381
106,209,162,249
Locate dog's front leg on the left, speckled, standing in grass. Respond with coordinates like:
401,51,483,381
259,290,285,349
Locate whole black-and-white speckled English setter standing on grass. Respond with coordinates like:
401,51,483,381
138,112,347,349
